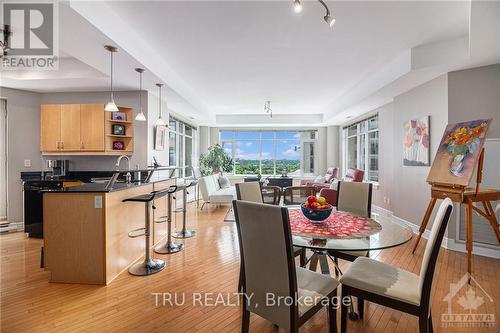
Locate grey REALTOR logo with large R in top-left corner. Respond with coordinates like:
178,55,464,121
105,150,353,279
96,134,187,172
2,2,58,70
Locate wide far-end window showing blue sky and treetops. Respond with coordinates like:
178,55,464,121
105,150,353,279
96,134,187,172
220,130,316,175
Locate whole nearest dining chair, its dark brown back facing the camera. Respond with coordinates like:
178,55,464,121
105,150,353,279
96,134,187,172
233,200,338,333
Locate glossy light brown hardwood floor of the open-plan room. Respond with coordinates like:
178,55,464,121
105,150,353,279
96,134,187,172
0,201,500,333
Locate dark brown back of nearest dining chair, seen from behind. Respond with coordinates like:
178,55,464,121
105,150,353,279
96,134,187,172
233,200,298,328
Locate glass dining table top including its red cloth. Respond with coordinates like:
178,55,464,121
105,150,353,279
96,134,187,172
288,206,413,251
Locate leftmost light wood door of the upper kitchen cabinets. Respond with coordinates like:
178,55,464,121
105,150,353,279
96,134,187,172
40,104,61,151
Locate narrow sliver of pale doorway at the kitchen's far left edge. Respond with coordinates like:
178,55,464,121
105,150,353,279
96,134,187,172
0,99,7,221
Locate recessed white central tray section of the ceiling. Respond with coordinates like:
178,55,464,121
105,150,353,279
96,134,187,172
96,1,469,123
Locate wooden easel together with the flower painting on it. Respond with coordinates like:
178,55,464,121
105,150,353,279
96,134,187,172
413,119,500,276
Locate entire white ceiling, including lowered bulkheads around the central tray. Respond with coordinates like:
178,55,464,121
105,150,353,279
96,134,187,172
1,0,500,126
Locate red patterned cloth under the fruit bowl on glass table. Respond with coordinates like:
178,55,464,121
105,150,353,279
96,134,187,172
289,209,382,239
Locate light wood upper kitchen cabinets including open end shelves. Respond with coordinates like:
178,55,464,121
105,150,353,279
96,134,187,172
40,104,134,155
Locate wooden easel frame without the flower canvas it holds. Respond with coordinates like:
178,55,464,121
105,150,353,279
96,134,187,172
413,148,500,275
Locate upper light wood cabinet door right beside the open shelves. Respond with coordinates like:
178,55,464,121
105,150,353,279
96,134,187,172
80,104,104,151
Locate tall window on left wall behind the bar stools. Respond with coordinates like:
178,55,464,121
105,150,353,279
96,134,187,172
168,117,196,177
